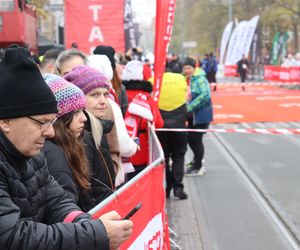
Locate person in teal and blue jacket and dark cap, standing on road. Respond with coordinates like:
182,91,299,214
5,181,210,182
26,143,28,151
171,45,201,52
183,58,213,176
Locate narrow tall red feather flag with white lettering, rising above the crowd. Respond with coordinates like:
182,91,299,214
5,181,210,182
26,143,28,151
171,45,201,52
153,0,176,102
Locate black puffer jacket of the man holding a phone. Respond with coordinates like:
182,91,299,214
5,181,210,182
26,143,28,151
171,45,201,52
0,131,109,250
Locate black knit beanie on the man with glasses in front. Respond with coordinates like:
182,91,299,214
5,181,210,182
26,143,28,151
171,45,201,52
0,45,58,119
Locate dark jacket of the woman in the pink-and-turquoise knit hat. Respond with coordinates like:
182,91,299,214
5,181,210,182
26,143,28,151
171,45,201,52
44,133,112,212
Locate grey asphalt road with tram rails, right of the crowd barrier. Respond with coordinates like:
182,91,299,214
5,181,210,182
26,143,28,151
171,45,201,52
168,122,300,250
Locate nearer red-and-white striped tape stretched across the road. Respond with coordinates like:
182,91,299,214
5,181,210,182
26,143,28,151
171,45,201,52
156,128,300,135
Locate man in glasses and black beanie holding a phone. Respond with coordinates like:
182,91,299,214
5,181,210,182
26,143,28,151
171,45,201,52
0,46,132,250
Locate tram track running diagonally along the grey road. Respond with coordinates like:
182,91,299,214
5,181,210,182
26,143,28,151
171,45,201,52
212,133,300,250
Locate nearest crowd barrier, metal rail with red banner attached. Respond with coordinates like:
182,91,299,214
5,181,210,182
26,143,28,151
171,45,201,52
89,127,170,250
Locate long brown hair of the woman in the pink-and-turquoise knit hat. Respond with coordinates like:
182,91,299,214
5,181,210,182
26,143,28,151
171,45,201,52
52,112,91,191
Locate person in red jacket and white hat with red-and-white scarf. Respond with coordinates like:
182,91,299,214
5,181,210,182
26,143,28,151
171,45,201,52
122,60,164,179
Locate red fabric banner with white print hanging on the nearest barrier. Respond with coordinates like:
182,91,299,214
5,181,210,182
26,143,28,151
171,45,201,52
89,165,170,250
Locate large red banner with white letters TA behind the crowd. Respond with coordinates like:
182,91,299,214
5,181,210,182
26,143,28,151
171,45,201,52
65,0,125,54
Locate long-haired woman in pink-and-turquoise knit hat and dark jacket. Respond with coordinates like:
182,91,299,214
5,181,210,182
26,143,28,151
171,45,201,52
44,74,115,212
